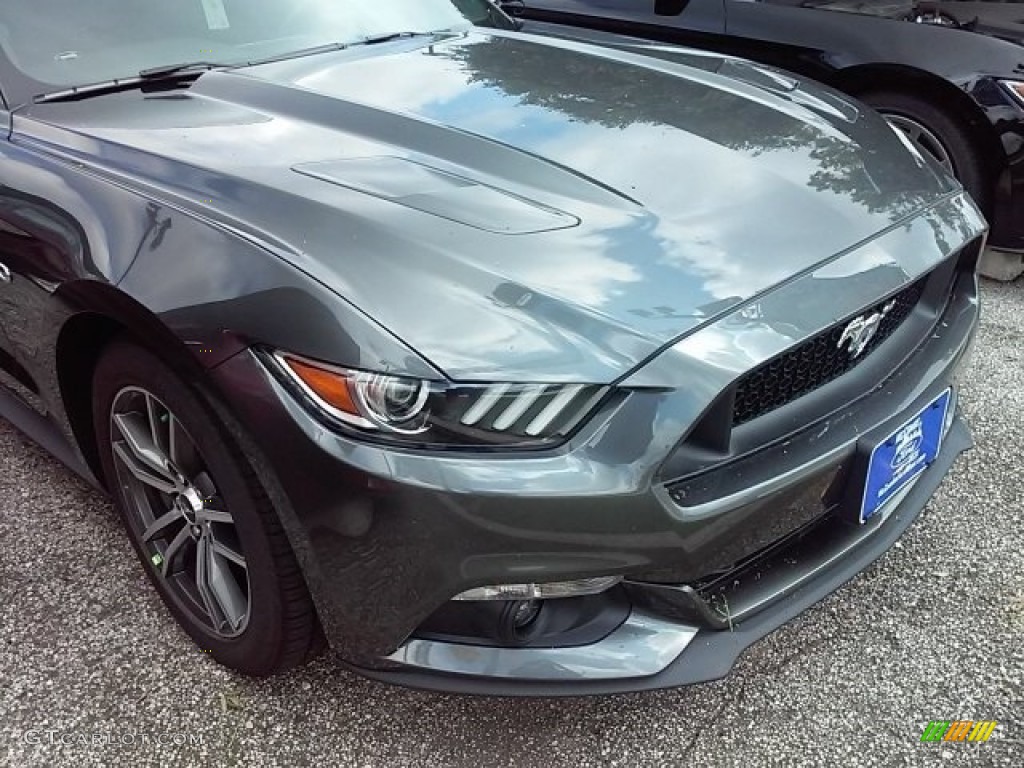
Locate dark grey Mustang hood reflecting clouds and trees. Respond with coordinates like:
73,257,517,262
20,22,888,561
15,31,958,382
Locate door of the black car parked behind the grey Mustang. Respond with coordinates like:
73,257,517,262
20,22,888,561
524,0,725,46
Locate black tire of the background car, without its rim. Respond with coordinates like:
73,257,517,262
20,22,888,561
859,91,993,213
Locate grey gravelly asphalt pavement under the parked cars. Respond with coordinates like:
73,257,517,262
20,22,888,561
0,279,1024,768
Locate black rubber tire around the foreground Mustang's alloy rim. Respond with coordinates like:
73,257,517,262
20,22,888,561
92,340,324,677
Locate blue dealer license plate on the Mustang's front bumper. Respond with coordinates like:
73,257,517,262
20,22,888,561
860,389,951,522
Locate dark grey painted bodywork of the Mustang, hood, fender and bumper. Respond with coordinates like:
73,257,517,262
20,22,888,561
0,7,986,691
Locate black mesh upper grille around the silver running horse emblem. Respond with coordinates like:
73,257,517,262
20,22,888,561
732,278,926,426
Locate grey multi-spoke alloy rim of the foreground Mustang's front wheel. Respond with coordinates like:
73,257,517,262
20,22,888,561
111,386,252,638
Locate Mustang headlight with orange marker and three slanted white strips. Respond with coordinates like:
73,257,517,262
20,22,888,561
268,351,609,447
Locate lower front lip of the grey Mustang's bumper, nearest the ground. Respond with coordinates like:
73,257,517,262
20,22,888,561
357,418,972,696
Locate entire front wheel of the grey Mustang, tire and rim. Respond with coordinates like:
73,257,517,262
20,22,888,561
93,342,321,675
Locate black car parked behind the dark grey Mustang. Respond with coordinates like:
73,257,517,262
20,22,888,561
516,0,1024,251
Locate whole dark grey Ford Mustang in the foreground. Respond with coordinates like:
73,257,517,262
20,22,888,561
0,0,986,693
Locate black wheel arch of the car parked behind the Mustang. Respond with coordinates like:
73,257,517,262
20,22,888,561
828,63,1009,196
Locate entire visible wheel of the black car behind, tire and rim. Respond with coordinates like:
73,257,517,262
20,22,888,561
860,91,992,210
